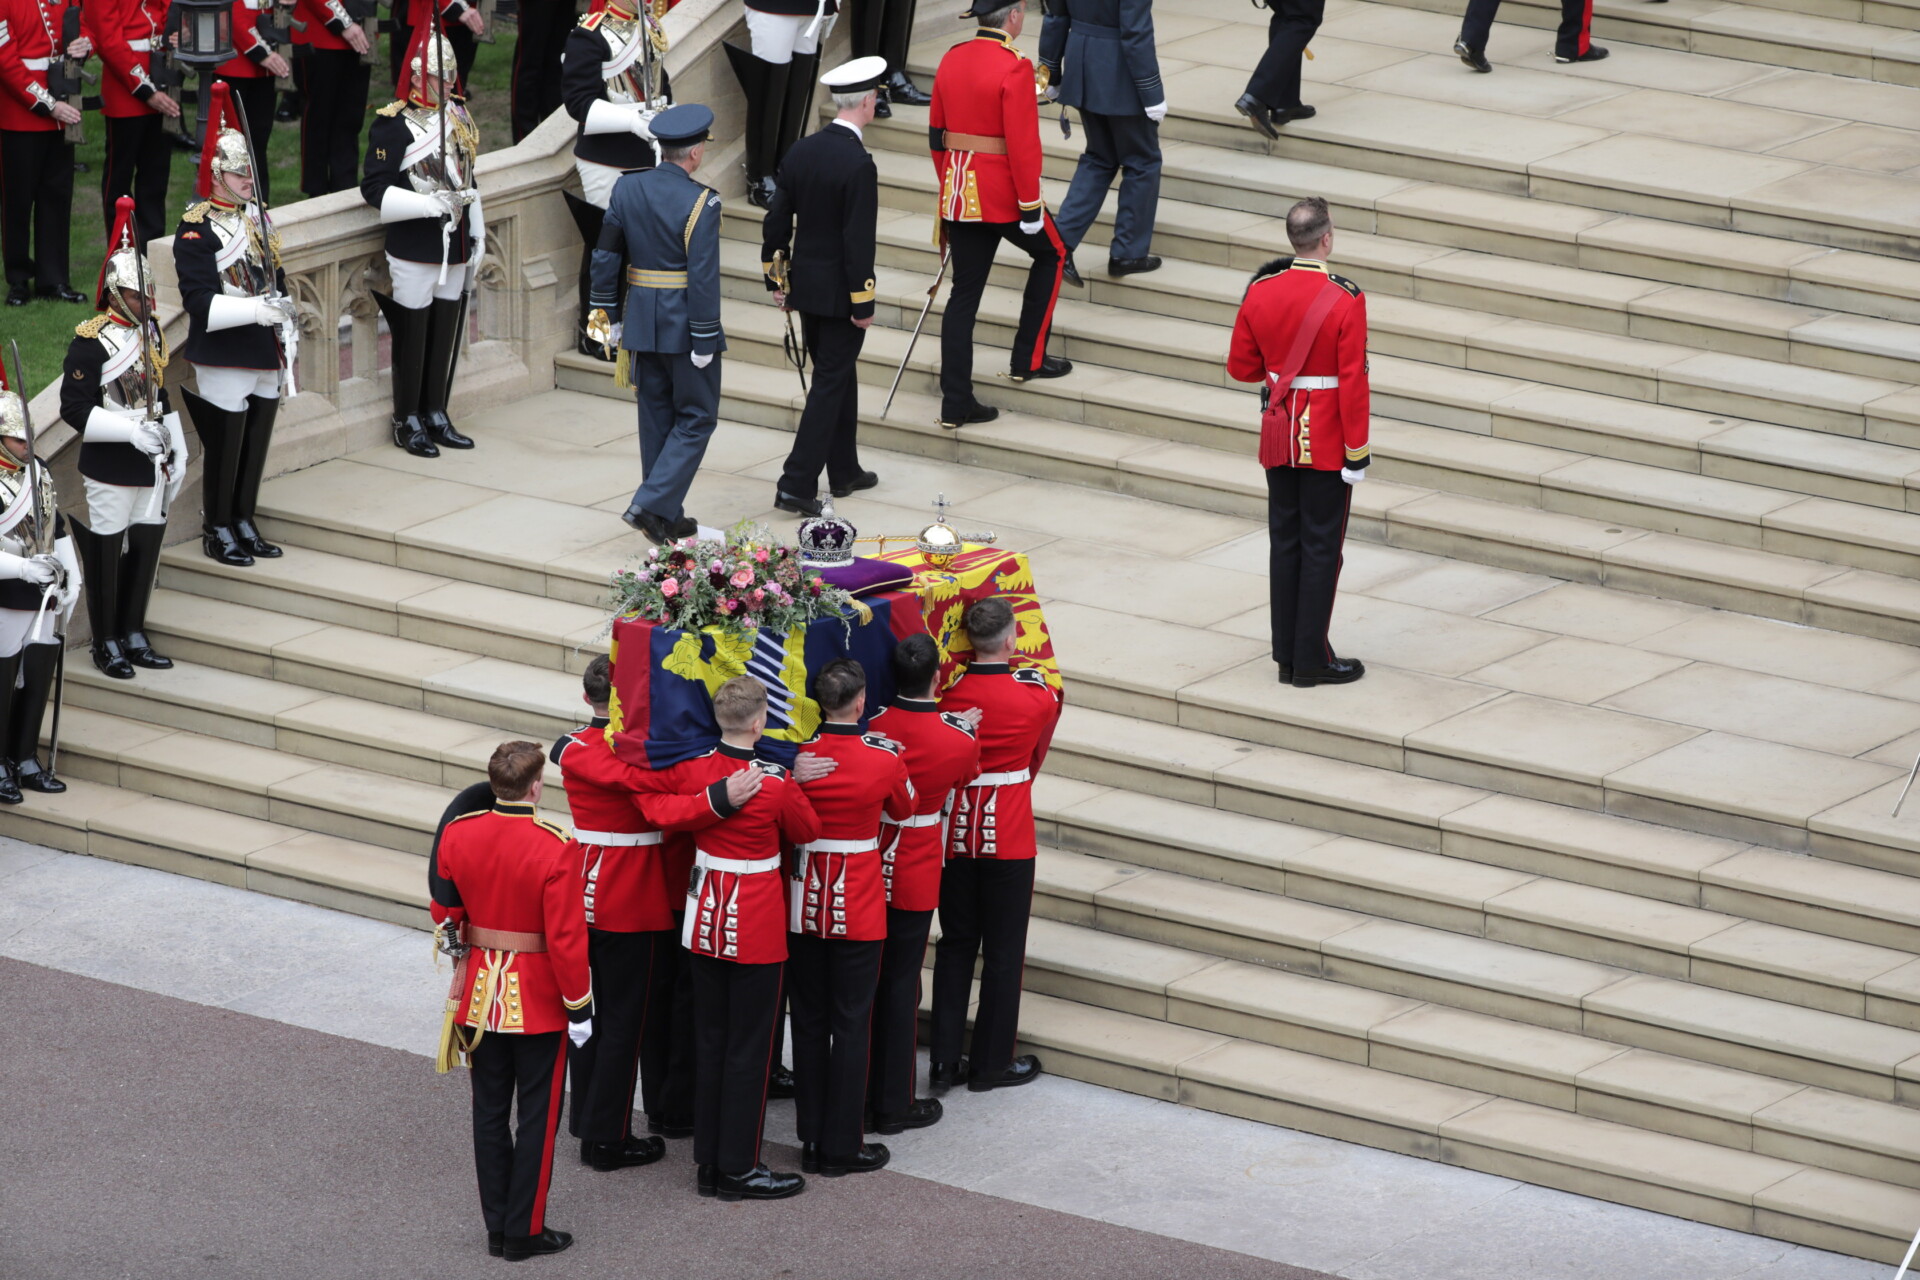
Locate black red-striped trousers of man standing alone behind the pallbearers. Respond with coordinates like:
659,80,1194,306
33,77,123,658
472,1031,566,1236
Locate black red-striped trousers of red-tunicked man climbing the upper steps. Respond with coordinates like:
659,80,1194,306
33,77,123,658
941,213,1068,422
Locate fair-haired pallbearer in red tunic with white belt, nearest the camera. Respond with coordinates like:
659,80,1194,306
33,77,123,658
625,676,820,1199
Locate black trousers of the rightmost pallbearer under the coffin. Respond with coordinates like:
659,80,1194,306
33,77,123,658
931,858,1033,1075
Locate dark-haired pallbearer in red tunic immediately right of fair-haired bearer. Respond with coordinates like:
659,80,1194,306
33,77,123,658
787,658,914,1178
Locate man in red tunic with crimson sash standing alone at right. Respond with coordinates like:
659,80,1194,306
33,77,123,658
1227,196,1371,689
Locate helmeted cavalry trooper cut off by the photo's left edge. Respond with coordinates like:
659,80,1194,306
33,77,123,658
0,360,81,804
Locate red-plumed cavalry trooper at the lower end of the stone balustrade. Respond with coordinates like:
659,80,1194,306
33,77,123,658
173,83,298,566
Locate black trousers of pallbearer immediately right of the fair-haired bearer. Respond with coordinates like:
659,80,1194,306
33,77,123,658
787,933,885,1161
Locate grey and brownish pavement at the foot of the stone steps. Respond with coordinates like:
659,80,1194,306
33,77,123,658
0,841,1885,1280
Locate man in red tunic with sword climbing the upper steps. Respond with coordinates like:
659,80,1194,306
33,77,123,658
927,0,1073,430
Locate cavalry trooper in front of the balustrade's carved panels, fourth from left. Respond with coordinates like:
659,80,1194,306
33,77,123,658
361,25,486,459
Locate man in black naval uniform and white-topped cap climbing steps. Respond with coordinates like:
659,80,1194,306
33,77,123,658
760,58,887,516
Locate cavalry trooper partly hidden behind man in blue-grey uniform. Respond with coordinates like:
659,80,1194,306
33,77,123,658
561,0,666,359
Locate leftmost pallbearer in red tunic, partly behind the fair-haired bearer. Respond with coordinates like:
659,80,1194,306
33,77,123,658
549,654,693,1173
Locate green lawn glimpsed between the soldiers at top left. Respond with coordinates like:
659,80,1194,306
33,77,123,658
0,29,513,393
